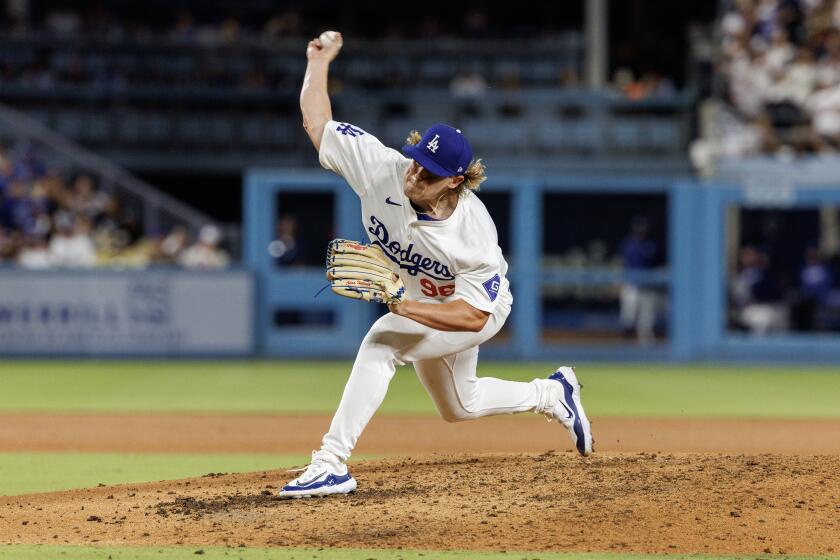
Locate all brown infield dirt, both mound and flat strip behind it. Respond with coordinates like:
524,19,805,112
0,414,840,554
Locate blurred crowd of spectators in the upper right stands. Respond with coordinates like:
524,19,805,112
701,0,840,158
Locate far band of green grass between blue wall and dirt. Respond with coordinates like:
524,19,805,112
0,361,840,418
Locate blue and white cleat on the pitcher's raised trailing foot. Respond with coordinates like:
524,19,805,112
538,366,594,457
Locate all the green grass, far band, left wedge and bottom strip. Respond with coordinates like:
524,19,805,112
0,361,840,560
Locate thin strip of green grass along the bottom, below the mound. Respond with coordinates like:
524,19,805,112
0,545,838,560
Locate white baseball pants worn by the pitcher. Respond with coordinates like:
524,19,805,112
321,301,542,461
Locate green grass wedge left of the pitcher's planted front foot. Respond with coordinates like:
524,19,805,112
0,453,309,496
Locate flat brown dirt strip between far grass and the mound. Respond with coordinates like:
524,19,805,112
0,413,840,455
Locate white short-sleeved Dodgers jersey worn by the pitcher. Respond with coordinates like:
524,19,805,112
320,121,512,312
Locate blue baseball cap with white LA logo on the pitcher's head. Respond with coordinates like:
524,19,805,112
402,124,472,177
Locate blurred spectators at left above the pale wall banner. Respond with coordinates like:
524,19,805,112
0,145,229,269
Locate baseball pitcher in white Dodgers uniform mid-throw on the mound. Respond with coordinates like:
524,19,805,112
280,32,593,498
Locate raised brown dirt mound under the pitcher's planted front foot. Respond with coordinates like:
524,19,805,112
0,453,840,554
